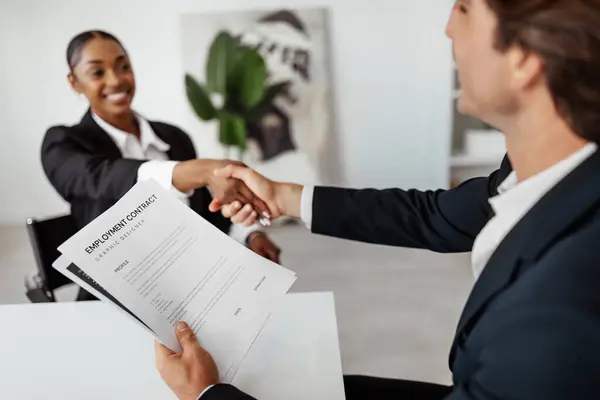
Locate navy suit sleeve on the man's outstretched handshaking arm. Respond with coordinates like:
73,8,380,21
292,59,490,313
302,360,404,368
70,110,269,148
311,158,509,253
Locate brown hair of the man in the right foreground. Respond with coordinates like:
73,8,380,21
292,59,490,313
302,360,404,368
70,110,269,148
485,0,600,143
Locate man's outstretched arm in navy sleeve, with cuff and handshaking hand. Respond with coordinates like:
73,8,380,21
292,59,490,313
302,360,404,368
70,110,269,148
212,158,511,252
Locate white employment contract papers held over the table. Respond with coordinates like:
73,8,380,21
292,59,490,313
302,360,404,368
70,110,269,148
54,181,296,382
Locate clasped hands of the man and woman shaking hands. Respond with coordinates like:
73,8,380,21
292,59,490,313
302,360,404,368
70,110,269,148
208,161,302,226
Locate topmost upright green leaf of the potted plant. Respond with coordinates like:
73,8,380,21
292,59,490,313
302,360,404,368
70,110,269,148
206,31,239,95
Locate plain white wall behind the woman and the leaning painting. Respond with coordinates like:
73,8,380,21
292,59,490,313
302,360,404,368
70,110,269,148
0,0,453,224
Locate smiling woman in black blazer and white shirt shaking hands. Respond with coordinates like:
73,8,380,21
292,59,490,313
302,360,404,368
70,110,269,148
41,31,280,300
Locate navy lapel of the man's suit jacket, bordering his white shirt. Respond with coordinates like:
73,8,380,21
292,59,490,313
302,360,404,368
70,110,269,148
450,150,600,362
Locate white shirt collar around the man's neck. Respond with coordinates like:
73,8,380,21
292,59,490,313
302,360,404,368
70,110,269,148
489,143,598,215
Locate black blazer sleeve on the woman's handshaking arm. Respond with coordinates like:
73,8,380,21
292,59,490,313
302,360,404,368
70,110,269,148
41,127,145,202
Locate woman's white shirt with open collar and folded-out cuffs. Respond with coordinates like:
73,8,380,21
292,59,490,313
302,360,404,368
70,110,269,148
92,113,259,244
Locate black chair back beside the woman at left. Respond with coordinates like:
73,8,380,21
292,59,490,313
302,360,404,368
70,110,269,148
27,215,77,302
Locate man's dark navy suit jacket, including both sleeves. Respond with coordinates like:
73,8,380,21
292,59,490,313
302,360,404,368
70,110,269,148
207,152,600,400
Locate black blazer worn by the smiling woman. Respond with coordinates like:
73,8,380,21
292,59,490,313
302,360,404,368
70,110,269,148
41,110,231,233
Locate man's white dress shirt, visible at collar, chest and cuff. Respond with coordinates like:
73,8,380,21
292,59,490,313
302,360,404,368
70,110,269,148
300,143,598,279
